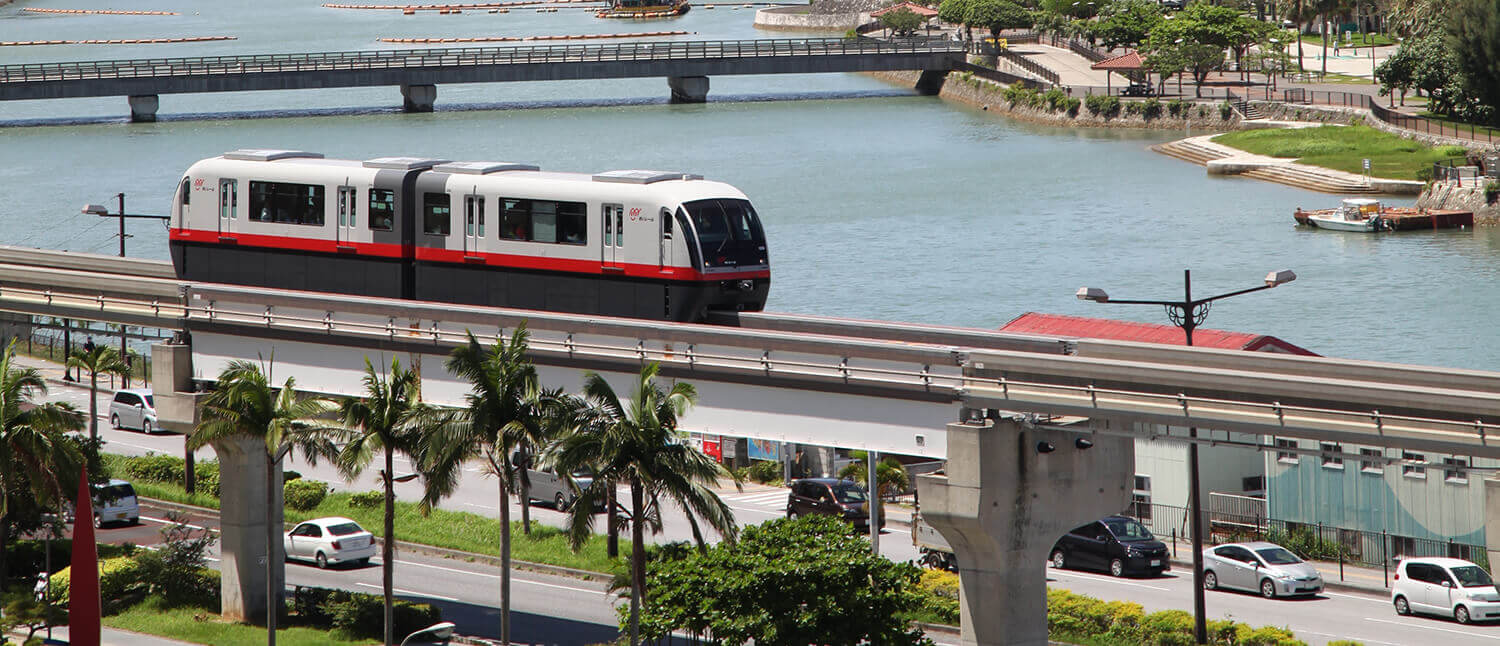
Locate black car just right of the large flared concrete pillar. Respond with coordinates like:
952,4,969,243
1052,516,1172,577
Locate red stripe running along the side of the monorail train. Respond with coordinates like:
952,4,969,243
171,229,771,280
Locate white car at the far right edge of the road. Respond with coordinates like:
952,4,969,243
1391,558,1500,624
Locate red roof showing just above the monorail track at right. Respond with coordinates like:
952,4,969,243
1001,312,1317,357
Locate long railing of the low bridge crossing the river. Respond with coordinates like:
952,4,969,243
0,37,963,82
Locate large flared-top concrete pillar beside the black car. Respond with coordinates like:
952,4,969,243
917,417,1136,646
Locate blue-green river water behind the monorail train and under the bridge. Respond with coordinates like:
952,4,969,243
0,0,1500,369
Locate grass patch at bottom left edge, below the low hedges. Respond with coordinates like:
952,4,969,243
104,598,378,646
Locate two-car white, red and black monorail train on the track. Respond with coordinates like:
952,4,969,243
170,150,771,321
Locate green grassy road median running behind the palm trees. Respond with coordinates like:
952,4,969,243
102,454,630,573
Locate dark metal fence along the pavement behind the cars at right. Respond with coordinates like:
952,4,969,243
1127,495,1488,578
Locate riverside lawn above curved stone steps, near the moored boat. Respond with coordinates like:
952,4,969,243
1214,126,1464,180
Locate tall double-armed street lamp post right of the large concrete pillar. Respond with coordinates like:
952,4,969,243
1077,270,1298,645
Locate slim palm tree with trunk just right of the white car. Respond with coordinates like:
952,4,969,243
338,357,425,646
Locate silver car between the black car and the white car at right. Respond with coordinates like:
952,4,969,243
1203,543,1323,600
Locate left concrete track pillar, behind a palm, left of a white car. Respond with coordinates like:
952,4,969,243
213,438,287,625
